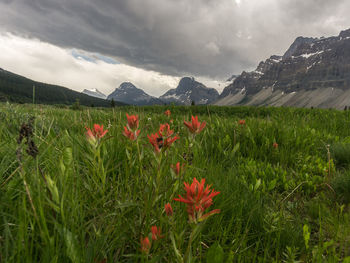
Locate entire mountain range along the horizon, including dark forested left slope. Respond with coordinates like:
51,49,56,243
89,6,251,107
0,29,350,109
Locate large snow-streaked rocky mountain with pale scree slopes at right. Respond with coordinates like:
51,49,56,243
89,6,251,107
215,29,350,108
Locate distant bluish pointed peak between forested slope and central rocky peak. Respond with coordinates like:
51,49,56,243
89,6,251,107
107,82,164,106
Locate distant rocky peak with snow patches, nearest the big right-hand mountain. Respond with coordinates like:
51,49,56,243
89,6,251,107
159,77,219,105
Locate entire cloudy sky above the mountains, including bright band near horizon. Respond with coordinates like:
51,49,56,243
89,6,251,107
0,0,350,96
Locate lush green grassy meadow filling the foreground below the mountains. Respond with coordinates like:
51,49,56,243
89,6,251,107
0,103,350,263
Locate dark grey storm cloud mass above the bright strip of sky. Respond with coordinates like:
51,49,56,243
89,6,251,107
0,0,350,78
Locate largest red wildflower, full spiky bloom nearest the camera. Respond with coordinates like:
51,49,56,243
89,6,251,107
174,178,220,223
